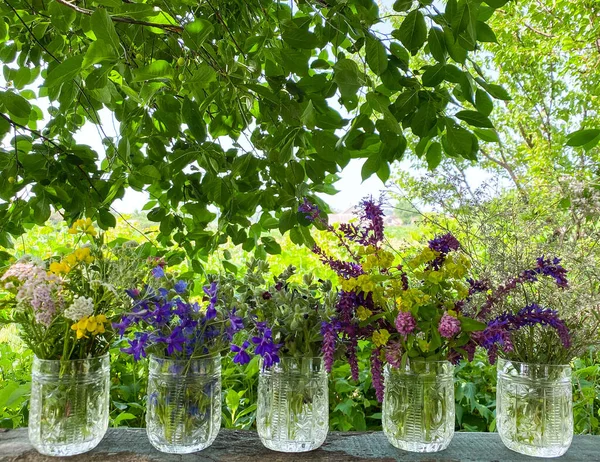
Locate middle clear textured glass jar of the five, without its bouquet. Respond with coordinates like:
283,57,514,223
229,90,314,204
256,358,329,452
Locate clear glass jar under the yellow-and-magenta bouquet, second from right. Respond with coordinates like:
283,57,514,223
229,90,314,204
382,360,455,452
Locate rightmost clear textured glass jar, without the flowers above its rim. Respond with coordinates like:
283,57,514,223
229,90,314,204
496,359,573,457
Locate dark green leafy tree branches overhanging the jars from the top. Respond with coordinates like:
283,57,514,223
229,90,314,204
0,0,507,260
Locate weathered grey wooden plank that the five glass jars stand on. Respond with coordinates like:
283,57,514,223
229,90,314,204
0,429,600,462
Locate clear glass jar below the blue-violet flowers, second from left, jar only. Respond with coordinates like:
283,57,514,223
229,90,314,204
146,356,221,454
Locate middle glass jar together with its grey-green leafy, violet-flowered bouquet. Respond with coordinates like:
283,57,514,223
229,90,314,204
219,260,336,452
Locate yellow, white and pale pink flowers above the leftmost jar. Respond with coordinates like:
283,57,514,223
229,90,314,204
0,218,147,360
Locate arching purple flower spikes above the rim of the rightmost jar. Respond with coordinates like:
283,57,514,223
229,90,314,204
470,256,600,365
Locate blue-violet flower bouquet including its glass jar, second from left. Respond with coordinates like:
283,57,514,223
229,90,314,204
113,268,239,453
